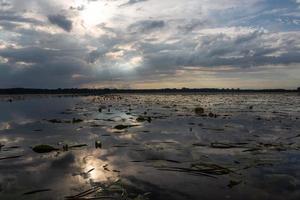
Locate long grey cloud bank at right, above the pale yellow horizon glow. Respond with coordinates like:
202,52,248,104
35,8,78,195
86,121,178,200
135,31,300,73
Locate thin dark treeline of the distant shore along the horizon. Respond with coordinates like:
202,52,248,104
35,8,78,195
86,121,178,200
0,88,300,95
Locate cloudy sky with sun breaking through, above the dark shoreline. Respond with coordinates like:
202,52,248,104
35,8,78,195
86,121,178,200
0,0,300,89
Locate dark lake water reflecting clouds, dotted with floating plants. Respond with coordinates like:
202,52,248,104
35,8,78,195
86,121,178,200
0,94,300,200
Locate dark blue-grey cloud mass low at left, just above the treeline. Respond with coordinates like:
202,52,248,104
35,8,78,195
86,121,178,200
0,48,92,87
